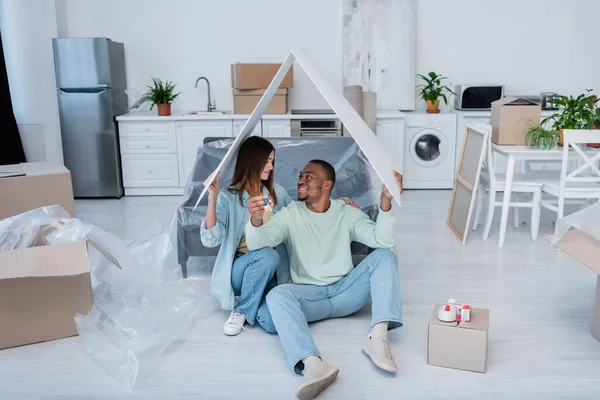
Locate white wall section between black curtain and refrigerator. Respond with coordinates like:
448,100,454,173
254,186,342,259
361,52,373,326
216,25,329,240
0,0,63,163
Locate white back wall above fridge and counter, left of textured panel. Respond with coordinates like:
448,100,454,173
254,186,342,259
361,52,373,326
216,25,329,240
66,0,343,112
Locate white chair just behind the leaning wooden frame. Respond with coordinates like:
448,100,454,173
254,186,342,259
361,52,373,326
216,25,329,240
473,124,542,241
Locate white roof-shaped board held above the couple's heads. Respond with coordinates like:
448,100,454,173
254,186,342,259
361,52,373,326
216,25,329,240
194,48,402,208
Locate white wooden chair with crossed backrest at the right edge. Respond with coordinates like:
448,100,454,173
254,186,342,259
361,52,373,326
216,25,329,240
540,129,600,218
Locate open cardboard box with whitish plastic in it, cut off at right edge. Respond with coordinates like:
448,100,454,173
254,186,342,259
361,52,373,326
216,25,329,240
547,203,600,340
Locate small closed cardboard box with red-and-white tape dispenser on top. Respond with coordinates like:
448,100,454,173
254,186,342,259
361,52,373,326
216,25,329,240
427,304,489,372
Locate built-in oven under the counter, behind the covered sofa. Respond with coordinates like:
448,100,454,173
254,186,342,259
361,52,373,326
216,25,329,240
291,110,343,137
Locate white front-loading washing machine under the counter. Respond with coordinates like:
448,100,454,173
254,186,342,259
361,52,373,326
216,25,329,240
403,112,456,189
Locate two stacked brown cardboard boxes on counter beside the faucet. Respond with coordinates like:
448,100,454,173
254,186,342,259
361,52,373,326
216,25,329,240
231,64,294,114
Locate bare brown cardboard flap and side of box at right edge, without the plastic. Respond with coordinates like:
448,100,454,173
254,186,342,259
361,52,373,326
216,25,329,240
556,229,600,340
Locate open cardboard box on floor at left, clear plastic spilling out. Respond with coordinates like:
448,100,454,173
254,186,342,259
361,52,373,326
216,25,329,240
0,223,120,349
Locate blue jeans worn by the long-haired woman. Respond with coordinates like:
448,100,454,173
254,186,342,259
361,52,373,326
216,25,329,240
231,247,279,325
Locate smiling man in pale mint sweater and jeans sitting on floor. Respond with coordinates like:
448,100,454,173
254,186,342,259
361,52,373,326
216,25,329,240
246,160,402,399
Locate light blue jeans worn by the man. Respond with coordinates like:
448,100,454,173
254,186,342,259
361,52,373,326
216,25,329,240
257,249,402,373
